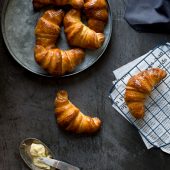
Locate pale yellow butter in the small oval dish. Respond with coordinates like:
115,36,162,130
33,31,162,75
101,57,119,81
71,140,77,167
30,143,50,170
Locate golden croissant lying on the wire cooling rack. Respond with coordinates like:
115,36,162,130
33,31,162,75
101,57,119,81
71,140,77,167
125,68,167,119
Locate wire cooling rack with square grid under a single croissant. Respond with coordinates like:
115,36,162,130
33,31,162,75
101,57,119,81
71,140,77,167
111,44,170,147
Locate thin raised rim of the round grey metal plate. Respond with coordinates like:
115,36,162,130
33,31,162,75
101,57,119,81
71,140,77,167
1,0,113,78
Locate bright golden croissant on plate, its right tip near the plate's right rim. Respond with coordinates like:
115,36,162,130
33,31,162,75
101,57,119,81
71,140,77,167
64,9,105,49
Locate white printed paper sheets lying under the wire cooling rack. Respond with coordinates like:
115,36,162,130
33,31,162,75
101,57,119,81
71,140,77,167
110,43,170,154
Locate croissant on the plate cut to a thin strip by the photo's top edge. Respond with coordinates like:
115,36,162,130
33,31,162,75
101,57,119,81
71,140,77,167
33,0,84,9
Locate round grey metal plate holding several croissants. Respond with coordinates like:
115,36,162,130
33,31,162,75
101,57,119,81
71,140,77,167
1,0,112,77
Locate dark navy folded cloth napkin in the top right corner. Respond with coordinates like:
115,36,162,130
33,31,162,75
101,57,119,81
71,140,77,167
125,0,170,33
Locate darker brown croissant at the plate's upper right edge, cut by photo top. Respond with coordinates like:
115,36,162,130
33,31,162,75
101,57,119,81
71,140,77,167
84,0,108,32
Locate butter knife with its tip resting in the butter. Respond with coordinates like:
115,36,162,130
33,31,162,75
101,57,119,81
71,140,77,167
39,157,80,170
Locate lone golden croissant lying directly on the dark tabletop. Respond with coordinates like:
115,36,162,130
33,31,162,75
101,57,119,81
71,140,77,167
55,90,101,134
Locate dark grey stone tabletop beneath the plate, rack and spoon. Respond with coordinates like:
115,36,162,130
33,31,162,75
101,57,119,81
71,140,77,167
0,0,170,170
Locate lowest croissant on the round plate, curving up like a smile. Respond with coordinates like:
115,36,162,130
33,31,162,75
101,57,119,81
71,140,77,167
35,45,84,76
